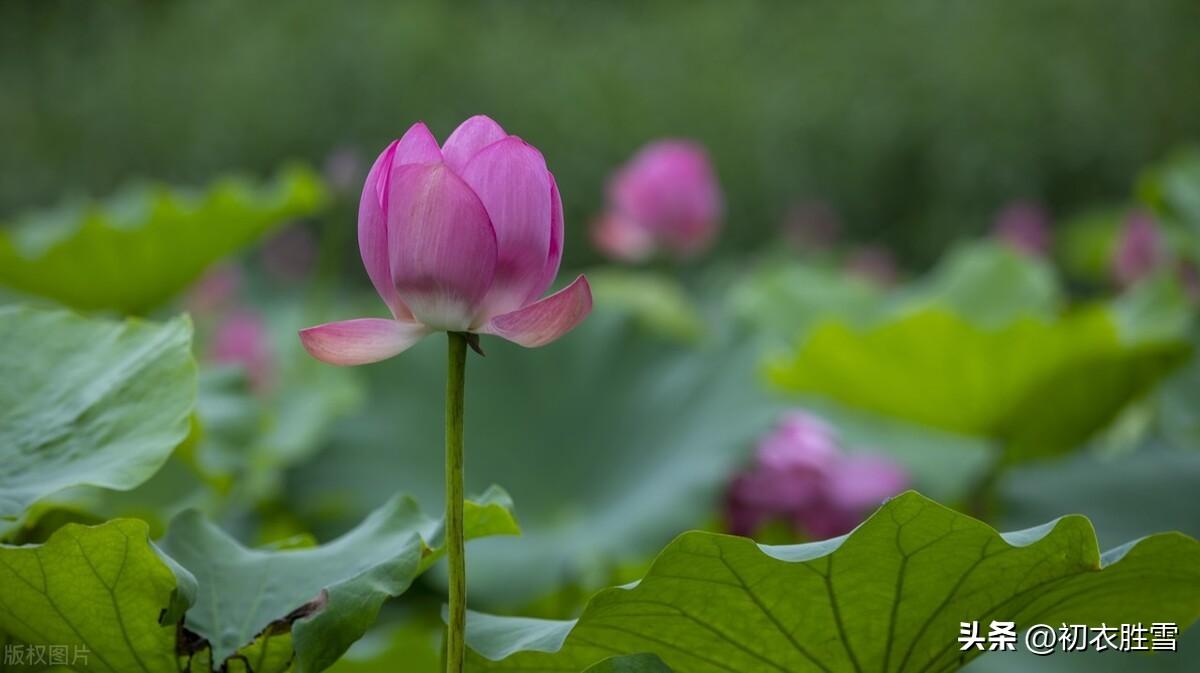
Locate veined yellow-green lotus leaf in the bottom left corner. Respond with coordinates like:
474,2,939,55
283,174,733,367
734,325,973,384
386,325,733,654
0,519,196,673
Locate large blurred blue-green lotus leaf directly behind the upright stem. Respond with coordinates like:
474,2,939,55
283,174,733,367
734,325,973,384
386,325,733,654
290,305,779,605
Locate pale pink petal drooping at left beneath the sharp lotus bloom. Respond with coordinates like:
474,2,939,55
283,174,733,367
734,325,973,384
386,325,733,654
300,318,430,366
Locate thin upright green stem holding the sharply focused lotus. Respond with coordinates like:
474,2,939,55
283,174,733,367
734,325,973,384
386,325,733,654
445,332,467,673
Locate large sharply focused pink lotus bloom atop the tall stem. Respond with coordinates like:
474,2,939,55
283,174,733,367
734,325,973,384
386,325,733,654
300,115,592,365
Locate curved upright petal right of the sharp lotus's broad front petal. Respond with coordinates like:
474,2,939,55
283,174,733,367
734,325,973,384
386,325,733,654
461,136,552,317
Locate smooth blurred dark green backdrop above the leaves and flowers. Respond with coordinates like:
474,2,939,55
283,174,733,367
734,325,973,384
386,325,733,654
0,0,1200,264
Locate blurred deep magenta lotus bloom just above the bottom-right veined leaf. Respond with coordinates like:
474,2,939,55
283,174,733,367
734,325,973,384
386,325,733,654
726,411,908,539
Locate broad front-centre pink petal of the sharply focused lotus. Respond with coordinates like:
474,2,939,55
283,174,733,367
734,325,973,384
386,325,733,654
388,163,496,331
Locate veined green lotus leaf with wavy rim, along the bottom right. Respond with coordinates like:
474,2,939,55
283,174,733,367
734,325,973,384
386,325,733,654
468,492,1200,673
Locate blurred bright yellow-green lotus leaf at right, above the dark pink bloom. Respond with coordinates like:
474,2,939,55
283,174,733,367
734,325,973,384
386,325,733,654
768,308,1190,461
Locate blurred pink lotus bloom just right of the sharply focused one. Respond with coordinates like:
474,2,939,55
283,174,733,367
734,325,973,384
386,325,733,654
592,140,721,262
